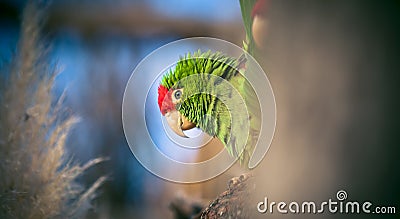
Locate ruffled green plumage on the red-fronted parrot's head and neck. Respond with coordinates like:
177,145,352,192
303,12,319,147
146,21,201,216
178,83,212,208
161,51,261,163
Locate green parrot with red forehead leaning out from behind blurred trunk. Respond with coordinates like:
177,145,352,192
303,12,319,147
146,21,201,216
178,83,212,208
158,1,261,164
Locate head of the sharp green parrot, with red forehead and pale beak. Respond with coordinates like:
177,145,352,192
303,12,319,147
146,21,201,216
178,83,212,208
158,51,241,137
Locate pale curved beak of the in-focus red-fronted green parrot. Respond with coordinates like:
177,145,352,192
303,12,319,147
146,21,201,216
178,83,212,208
165,110,195,138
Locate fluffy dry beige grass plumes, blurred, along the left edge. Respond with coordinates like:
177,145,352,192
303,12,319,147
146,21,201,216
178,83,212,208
0,2,106,218
